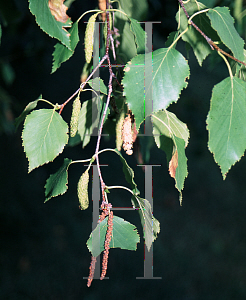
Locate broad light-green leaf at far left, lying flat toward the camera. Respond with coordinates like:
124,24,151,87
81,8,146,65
22,109,68,172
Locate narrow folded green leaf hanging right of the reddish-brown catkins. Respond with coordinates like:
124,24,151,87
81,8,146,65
132,196,160,251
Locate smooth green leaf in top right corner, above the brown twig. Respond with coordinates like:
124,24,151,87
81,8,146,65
207,7,244,61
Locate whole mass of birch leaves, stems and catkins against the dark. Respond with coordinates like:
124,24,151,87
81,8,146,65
4,0,246,283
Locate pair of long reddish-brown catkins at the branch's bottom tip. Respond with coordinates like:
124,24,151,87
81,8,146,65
87,202,113,287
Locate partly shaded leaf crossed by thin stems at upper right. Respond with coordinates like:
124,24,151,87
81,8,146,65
176,0,219,66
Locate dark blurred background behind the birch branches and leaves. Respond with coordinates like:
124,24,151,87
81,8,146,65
0,0,246,300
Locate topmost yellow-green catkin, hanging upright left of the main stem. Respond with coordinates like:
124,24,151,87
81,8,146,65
85,13,98,64
